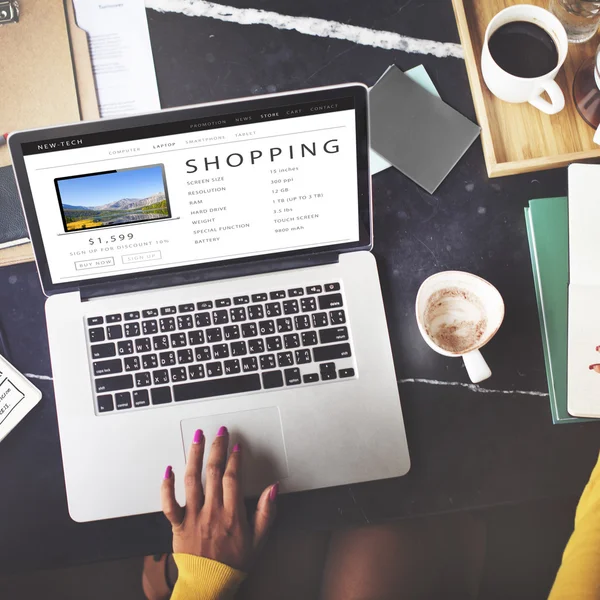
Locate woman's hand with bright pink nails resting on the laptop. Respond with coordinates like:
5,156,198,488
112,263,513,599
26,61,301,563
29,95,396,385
161,427,279,571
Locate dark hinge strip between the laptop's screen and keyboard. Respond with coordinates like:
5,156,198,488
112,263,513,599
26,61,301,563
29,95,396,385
80,253,339,301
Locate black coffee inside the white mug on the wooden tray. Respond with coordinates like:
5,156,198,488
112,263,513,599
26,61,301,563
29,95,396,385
488,21,558,77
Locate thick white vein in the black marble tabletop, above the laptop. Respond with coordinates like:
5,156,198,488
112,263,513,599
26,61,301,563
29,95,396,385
146,0,464,58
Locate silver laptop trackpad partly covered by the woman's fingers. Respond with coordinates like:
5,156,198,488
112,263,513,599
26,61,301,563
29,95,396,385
181,407,289,496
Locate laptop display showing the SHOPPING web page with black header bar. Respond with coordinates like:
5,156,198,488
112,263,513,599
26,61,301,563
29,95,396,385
23,98,359,283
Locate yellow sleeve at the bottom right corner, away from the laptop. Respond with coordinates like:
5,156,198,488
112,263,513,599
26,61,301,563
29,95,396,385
548,458,600,600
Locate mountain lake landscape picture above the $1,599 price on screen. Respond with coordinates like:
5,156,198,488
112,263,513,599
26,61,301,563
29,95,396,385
55,165,171,231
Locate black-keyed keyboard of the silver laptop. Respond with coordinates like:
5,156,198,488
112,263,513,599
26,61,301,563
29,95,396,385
86,282,356,413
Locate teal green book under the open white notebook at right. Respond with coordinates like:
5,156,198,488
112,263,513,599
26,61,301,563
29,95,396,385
525,197,590,424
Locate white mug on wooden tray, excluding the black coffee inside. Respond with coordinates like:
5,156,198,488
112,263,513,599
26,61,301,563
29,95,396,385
481,4,569,115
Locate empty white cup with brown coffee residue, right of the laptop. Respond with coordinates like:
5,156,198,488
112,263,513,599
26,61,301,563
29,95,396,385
416,271,504,383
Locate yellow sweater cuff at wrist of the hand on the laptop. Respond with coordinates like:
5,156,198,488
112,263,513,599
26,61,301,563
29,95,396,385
171,554,246,600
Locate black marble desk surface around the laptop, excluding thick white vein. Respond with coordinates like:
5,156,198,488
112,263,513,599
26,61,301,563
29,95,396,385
0,0,600,570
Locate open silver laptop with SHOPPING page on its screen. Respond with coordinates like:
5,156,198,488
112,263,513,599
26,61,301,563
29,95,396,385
8,84,409,522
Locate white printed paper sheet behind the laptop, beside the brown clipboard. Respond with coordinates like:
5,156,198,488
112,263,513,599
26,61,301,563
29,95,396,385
75,0,160,118
